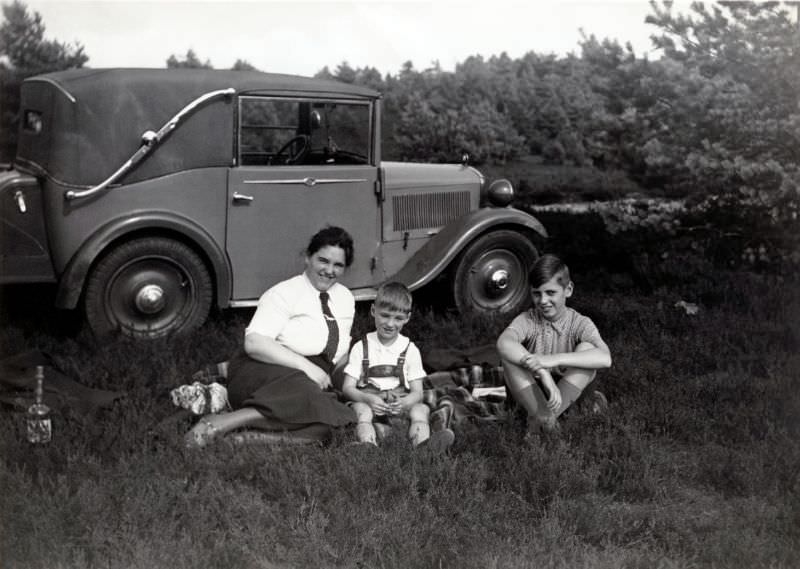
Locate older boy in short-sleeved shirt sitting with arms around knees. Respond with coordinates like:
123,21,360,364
497,255,611,434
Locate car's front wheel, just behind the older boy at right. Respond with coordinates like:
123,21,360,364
453,229,539,313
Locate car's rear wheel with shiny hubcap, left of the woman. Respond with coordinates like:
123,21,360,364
85,237,213,339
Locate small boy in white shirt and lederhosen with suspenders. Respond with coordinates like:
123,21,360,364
342,282,455,452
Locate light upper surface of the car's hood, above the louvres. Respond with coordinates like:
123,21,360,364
381,162,483,191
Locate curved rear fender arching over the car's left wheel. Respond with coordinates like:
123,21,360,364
56,212,231,308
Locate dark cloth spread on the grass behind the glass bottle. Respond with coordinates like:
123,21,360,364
0,350,124,414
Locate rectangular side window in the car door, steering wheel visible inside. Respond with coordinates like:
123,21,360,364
239,97,372,166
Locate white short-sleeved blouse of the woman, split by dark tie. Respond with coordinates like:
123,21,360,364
244,273,356,362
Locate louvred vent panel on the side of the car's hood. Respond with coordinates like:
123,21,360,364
392,192,469,231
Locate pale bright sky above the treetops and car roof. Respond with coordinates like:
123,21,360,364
23,0,683,75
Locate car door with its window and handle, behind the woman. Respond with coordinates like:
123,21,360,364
226,97,381,301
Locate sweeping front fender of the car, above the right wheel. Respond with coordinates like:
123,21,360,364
392,207,547,290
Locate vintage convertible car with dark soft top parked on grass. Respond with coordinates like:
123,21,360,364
0,69,546,338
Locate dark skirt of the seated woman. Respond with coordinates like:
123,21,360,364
223,351,356,427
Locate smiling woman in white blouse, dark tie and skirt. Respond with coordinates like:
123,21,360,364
187,227,356,446
